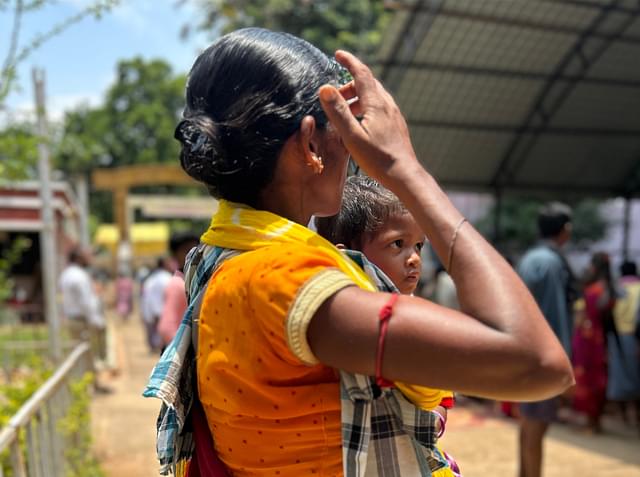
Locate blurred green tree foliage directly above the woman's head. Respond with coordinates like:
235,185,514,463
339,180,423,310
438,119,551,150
183,0,389,56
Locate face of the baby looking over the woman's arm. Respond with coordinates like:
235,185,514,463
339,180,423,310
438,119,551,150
362,213,425,295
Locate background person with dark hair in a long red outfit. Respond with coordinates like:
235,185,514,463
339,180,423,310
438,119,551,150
573,252,616,433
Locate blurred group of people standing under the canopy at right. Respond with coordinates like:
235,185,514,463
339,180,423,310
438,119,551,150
424,202,640,477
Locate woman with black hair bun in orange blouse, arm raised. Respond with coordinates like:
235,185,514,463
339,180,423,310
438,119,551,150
145,28,573,476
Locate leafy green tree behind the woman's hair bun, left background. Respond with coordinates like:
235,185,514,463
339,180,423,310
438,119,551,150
56,58,186,173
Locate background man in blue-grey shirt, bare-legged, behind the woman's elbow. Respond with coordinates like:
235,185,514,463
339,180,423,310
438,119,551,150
517,202,576,477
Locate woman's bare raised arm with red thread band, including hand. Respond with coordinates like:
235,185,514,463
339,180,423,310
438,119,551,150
307,52,573,400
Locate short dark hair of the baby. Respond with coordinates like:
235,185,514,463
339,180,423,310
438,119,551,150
315,176,407,250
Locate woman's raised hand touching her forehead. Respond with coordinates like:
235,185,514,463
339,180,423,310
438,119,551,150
319,51,422,190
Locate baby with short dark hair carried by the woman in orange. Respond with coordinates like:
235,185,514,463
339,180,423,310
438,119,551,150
315,176,458,477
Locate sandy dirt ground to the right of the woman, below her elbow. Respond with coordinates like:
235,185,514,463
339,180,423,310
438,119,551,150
441,400,640,477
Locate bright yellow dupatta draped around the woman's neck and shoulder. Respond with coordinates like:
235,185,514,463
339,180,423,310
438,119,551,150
200,200,451,410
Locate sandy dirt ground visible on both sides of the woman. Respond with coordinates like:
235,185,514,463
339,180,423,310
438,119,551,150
92,317,640,477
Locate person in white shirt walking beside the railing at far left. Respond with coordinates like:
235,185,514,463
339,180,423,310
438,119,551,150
59,248,110,392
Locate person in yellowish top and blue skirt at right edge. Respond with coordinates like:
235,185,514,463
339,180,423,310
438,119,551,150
607,261,640,430
